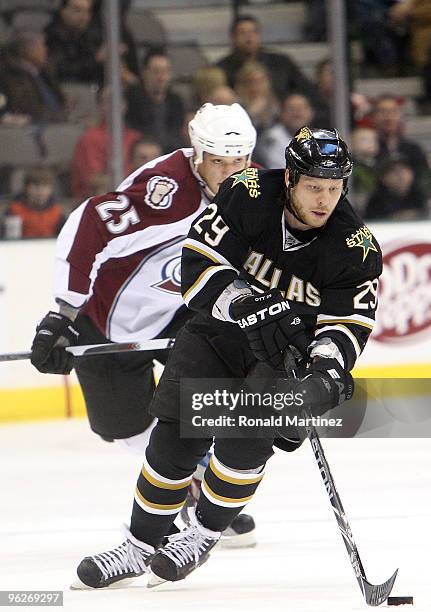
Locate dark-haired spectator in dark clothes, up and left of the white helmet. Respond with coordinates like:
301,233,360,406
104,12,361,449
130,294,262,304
126,50,185,153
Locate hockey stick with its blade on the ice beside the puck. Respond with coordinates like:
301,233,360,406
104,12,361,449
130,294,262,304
301,409,398,606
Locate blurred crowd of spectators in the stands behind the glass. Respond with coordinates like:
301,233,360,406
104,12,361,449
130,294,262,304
0,0,431,238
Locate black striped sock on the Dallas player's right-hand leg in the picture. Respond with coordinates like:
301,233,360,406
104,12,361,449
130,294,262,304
196,455,264,531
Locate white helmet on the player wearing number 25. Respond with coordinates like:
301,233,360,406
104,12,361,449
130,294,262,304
189,102,256,164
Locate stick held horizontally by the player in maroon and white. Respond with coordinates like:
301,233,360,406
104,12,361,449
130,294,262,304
0,338,175,362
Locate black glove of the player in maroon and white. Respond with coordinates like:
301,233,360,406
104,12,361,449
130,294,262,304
30,311,79,374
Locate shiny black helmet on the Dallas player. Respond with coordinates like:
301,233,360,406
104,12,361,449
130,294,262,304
285,126,353,187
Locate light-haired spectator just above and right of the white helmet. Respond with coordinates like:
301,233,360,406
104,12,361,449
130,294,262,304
234,61,280,132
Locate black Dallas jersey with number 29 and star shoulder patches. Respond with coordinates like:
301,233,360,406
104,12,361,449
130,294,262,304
182,168,382,370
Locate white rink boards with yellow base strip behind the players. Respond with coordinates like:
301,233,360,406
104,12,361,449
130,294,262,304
0,222,431,422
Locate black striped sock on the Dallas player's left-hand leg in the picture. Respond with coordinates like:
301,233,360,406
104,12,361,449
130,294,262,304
130,457,192,547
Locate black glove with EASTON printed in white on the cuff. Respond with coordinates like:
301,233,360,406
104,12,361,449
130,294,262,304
230,290,309,369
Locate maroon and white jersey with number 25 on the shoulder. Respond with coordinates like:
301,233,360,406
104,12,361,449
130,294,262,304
54,149,208,342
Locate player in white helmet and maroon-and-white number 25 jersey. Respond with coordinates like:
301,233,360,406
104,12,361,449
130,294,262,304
31,104,256,544
